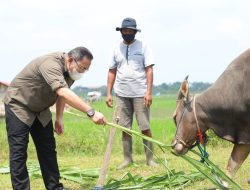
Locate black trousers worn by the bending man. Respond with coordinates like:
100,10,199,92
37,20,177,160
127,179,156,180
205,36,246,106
5,105,63,190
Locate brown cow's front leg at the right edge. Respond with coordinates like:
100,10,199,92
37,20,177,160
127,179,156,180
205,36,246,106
227,144,250,177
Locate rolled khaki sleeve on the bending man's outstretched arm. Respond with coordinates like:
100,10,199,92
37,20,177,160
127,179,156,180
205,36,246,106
39,60,69,91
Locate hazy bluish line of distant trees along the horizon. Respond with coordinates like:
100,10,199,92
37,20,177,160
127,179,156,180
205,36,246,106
73,82,212,97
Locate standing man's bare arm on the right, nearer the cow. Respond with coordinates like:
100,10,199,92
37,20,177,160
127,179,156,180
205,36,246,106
144,65,153,108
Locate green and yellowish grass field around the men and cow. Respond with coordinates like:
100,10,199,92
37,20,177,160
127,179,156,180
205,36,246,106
0,97,250,190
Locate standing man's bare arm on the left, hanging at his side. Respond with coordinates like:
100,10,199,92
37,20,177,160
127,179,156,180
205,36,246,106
106,68,116,108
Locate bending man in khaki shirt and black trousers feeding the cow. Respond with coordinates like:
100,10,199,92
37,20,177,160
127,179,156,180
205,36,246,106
4,47,106,190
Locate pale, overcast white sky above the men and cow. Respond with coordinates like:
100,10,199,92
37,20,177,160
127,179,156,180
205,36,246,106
0,0,250,87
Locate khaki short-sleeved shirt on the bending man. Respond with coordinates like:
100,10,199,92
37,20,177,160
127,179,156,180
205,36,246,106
4,52,74,126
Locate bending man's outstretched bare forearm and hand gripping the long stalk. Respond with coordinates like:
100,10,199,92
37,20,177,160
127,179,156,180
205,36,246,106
56,87,106,124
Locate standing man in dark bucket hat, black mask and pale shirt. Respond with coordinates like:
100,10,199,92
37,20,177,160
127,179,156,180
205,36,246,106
106,18,157,169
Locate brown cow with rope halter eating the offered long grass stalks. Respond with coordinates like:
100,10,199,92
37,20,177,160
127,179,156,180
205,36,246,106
173,49,250,177
